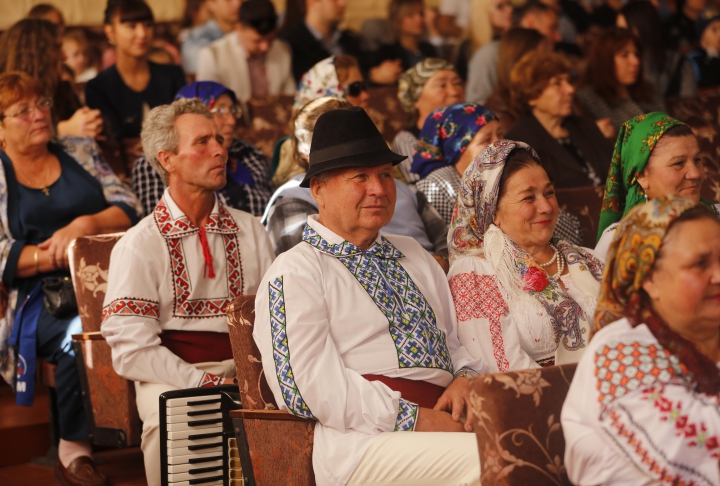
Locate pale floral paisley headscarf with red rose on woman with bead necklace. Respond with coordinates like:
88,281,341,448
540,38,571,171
448,140,603,364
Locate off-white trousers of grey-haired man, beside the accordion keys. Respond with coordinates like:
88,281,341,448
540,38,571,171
135,359,235,486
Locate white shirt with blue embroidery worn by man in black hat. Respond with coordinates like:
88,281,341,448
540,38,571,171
253,216,485,486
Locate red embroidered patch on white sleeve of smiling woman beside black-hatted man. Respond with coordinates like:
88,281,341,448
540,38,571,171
450,273,510,373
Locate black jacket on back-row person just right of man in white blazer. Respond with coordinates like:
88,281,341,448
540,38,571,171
278,22,367,82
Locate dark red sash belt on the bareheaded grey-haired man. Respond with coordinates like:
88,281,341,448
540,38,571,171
160,331,233,364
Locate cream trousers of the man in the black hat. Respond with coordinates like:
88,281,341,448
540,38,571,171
347,432,480,486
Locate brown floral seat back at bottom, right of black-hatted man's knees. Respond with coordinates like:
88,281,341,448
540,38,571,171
470,364,577,486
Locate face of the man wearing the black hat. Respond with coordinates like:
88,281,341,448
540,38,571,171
310,163,396,241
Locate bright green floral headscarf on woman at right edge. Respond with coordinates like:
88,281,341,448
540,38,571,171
598,112,712,239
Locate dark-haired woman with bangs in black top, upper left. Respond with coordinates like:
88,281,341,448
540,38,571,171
85,0,185,168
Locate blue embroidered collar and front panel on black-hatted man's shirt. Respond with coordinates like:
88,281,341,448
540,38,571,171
303,226,453,373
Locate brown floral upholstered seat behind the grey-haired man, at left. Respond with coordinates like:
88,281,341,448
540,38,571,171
69,234,141,447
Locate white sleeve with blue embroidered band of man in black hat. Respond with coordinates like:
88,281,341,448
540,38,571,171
253,252,418,434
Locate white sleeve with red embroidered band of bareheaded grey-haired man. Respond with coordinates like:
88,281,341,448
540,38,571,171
100,241,204,388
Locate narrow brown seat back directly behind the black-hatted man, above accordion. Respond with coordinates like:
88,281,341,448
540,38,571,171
227,295,277,410
